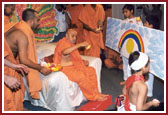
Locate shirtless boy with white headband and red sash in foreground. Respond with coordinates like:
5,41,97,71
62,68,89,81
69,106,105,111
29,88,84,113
118,51,160,111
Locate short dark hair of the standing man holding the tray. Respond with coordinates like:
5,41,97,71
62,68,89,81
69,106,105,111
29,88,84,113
22,8,37,22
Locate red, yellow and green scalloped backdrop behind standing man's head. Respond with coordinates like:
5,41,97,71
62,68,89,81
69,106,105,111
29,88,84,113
10,4,58,42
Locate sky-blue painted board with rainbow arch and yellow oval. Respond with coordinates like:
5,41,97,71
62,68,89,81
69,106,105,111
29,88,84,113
105,18,166,80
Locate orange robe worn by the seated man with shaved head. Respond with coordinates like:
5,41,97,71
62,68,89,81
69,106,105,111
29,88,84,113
53,38,100,101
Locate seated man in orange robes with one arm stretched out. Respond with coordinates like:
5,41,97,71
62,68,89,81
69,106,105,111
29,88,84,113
53,29,107,101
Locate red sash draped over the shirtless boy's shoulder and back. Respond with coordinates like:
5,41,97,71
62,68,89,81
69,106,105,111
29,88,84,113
124,75,145,111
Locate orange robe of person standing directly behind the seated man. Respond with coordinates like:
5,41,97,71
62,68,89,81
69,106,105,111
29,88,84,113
79,4,105,57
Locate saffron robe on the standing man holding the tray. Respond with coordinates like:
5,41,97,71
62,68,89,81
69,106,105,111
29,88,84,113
15,21,42,99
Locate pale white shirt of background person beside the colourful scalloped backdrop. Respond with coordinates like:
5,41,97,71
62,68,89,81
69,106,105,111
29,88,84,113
55,6,70,32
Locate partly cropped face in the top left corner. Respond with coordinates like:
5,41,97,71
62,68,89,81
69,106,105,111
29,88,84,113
4,4,15,16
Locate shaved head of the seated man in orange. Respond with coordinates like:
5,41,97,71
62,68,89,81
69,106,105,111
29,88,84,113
66,29,77,44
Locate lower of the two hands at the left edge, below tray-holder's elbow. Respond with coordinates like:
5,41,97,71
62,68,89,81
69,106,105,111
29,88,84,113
4,75,20,90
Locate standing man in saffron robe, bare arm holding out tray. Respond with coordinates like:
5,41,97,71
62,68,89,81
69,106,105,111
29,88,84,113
5,9,51,99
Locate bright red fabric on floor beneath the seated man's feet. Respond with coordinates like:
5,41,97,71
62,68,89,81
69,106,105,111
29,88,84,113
78,95,112,111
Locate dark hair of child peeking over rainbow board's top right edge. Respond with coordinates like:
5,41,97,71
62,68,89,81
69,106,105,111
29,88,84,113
146,15,160,29
